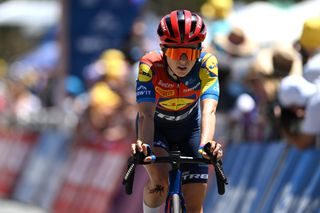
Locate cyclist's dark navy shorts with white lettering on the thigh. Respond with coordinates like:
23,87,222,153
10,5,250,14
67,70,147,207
153,115,208,184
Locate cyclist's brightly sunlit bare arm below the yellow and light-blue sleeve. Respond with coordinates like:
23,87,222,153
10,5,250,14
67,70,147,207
200,98,218,146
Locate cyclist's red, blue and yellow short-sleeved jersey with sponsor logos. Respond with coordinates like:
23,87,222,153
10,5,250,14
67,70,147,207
136,51,219,122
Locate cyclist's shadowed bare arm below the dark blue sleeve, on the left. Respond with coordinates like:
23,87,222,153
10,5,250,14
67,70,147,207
138,102,156,144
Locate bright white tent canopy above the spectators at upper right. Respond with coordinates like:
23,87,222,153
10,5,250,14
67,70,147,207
229,0,320,45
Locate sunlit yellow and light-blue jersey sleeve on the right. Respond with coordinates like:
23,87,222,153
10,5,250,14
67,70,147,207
199,53,220,101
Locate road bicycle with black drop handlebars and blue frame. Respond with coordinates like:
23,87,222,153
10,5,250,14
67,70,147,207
122,143,228,213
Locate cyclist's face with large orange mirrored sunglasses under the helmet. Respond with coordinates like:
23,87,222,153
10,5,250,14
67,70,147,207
165,45,201,77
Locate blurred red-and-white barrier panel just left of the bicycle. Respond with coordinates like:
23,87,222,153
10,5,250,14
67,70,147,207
53,142,129,213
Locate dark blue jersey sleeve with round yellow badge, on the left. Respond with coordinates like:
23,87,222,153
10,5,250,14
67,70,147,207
136,61,156,103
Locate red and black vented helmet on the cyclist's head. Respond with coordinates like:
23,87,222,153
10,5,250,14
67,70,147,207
157,10,207,46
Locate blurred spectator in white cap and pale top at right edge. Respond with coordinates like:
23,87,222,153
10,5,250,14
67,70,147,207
278,75,320,149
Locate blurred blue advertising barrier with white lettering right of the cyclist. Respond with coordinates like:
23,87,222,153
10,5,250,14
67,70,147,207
204,141,320,213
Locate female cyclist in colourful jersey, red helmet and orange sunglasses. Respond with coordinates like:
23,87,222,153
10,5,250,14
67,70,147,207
132,10,223,213
